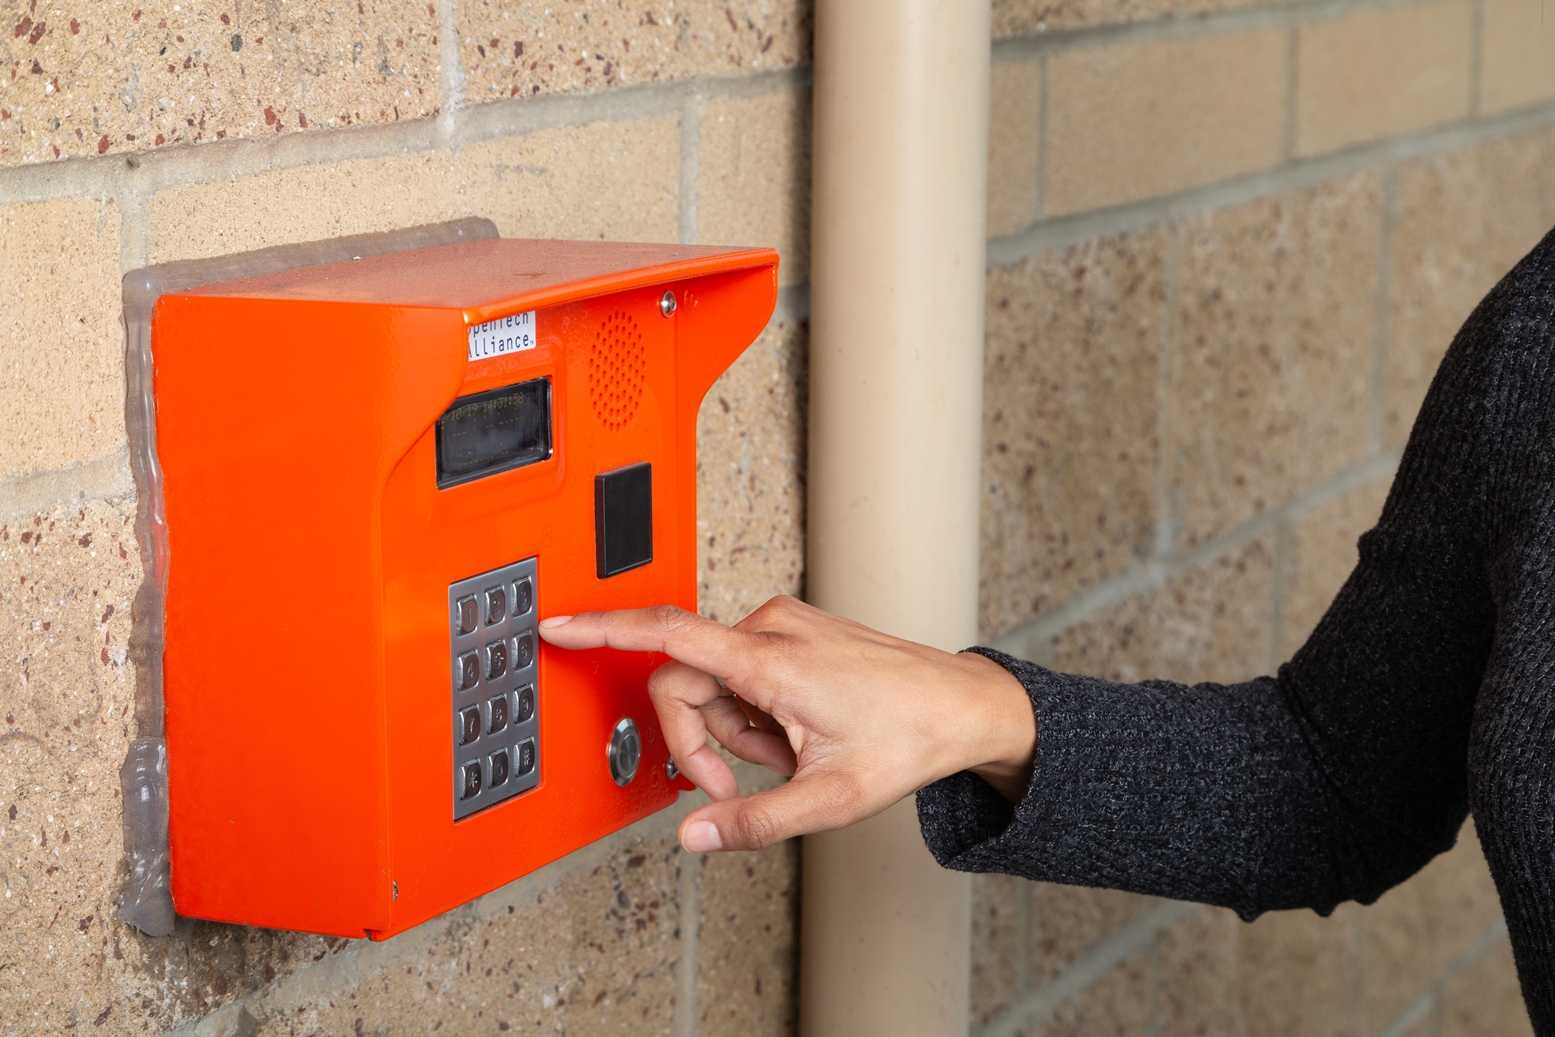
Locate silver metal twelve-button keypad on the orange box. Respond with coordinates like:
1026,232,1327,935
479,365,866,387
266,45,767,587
448,558,540,821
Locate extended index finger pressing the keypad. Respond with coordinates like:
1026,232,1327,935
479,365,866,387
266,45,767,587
540,605,760,693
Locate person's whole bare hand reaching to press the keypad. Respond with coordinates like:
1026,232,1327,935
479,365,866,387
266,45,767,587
540,597,1037,852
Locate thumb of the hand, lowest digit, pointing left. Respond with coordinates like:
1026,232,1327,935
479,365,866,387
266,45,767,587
680,770,863,854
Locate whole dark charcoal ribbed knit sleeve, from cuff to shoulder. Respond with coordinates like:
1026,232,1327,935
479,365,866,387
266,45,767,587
917,245,1494,917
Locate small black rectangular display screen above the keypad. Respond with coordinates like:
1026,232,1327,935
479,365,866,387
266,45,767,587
437,378,550,488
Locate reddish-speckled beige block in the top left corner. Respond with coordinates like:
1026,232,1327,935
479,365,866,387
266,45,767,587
0,0,439,165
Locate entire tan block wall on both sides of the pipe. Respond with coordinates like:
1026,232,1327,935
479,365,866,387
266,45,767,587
0,0,1555,1037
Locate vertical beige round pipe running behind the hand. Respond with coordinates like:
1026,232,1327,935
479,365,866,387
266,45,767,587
799,0,989,1037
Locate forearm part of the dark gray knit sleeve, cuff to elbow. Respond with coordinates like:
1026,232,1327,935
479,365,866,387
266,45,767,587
917,648,1344,914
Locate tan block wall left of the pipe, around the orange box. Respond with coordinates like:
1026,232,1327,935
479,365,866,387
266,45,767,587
0,0,810,1035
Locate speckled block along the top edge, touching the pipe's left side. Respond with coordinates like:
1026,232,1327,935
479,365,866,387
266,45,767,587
456,0,812,103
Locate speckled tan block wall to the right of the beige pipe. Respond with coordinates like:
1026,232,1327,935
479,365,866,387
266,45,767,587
972,0,1555,1037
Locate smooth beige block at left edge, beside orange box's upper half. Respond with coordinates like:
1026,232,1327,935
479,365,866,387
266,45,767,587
0,201,124,479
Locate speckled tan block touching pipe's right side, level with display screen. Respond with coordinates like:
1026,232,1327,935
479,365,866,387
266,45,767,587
980,232,1166,637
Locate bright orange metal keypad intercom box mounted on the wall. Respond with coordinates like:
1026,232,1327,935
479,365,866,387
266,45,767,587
151,239,778,937
